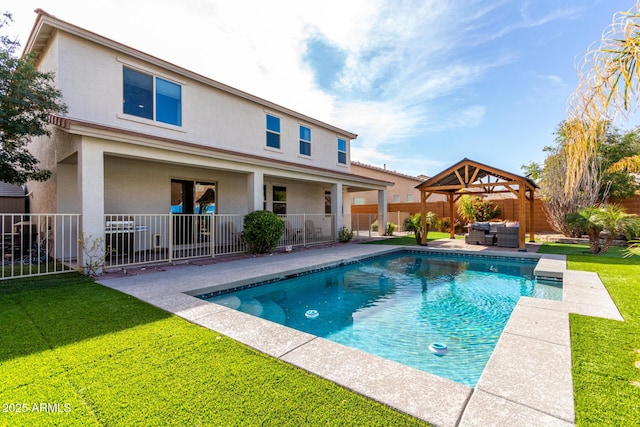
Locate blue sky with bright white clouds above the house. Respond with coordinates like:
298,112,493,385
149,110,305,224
0,0,635,175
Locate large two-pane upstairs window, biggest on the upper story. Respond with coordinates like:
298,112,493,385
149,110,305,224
123,67,182,126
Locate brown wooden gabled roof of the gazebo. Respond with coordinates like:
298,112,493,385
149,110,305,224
415,158,539,194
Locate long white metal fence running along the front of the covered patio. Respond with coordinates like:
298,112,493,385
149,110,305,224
0,214,336,279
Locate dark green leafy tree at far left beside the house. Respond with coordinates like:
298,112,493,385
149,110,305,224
0,12,67,184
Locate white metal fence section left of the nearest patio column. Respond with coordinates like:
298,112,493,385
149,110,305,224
0,214,81,279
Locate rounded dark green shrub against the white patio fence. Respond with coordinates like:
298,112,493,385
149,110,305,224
243,211,284,254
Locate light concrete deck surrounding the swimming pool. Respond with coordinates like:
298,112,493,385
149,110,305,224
98,240,623,426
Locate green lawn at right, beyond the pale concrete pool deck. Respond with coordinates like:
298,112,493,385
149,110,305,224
540,244,640,426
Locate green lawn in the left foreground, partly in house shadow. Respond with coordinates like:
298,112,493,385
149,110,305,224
0,274,426,426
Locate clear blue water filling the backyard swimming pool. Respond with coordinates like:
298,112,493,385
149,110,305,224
202,252,562,387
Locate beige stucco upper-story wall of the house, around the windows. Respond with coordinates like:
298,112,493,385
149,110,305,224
53,33,350,172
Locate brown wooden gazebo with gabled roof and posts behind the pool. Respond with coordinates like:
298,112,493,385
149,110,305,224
416,158,539,251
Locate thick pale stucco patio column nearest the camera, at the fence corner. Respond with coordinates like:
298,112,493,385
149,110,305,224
78,142,105,266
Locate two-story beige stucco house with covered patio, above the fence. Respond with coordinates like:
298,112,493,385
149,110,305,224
20,10,388,266
